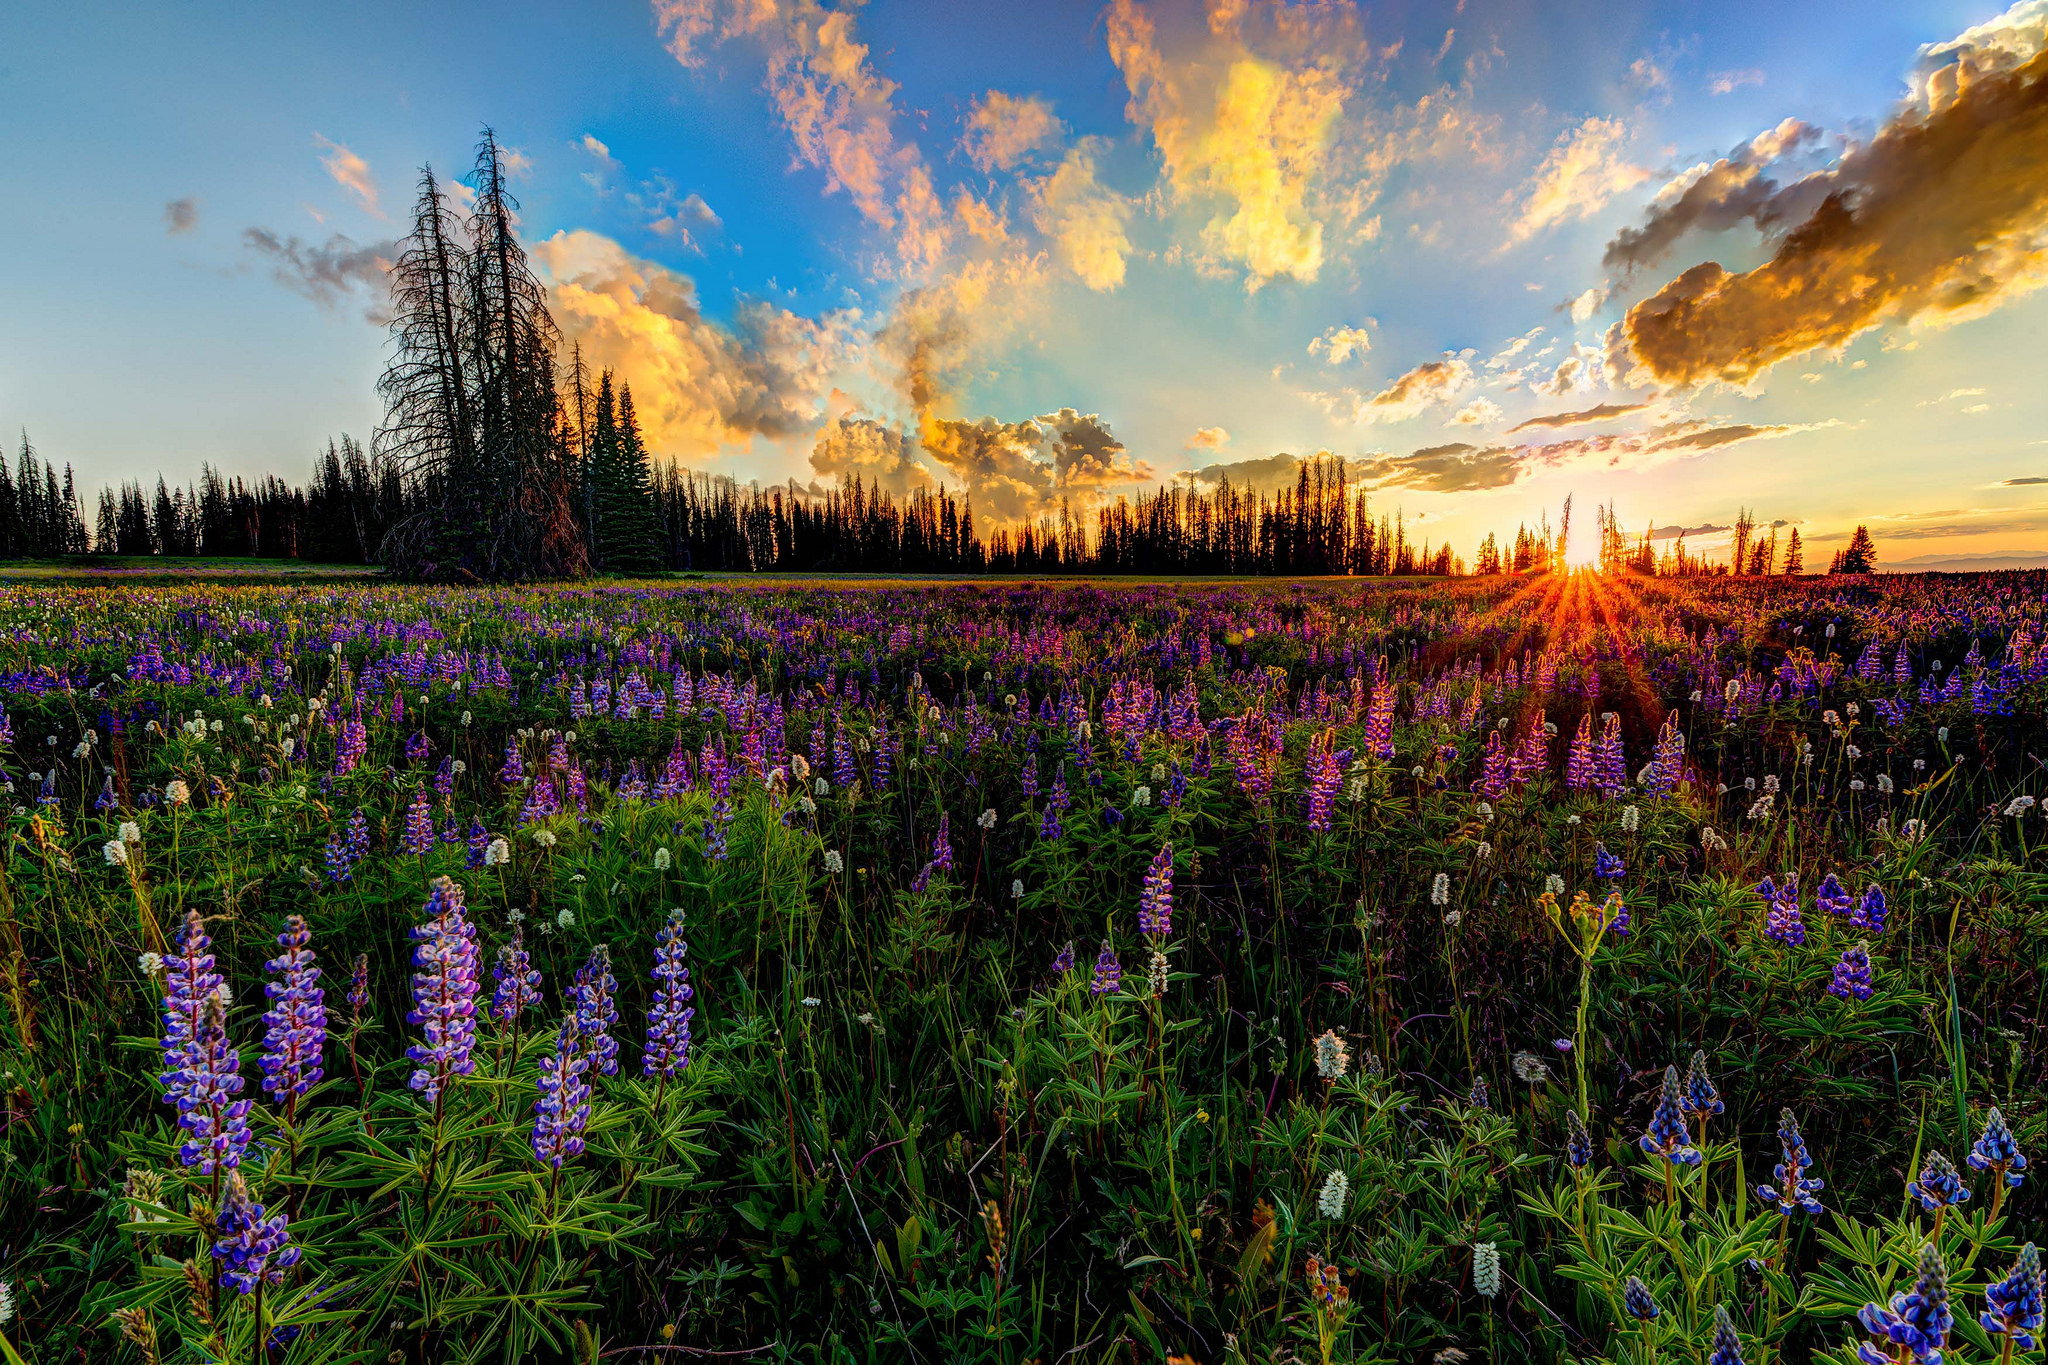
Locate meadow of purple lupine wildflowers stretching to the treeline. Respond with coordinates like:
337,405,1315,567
0,573,2048,1365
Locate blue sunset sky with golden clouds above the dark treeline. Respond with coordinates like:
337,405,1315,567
0,0,2048,569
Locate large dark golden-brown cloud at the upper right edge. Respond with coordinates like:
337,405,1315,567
1610,0,2048,385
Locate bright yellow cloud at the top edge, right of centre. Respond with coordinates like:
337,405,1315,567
1106,0,1366,289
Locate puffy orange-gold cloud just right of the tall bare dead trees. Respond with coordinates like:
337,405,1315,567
530,229,854,454
